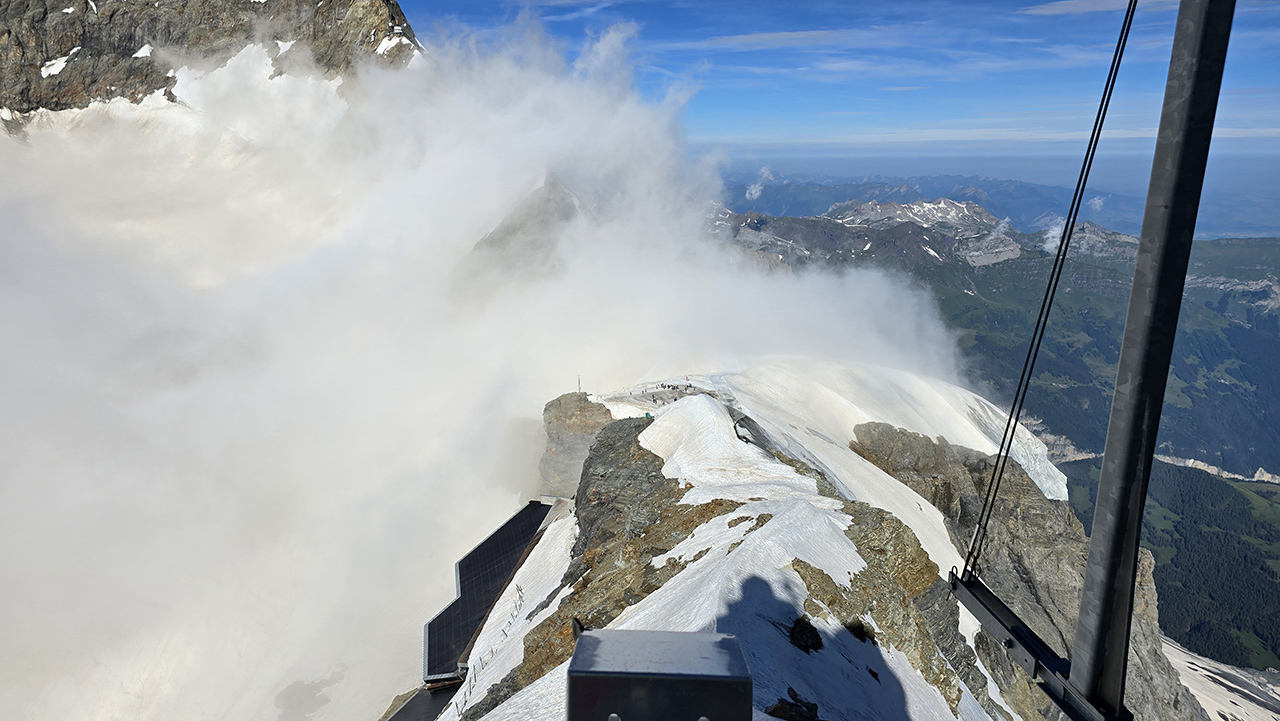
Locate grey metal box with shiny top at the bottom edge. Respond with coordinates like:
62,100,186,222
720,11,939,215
568,630,751,721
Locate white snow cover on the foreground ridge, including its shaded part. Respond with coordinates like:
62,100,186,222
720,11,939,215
442,360,1065,721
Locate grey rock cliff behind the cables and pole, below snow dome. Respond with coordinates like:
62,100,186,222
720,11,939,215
850,423,1207,721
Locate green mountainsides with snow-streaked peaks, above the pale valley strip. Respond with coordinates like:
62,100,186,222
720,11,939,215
710,201,1280,476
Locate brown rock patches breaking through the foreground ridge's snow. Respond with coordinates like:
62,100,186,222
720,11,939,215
463,412,1001,721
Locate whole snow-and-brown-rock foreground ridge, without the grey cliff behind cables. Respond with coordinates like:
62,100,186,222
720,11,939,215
440,359,1203,721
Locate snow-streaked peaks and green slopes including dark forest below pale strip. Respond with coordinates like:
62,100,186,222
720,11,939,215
709,195,1280,667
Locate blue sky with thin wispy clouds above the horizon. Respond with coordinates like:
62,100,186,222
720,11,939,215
401,0,1280,192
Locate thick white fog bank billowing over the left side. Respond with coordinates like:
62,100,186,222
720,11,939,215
0,28,955,721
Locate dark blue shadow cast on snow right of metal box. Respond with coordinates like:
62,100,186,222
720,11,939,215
716,576,910,721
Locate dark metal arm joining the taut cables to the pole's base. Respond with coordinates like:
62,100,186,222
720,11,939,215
951,569,1133,721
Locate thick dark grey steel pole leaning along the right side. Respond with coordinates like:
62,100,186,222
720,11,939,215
1070,0,1235,715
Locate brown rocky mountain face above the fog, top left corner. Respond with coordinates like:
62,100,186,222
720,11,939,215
0,0,419,118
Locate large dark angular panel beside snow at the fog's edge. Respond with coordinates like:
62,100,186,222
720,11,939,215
422,501,552,679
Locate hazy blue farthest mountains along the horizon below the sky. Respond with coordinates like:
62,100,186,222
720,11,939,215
723,173,1280,237
